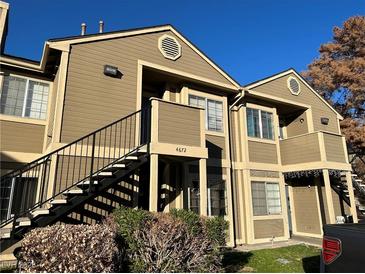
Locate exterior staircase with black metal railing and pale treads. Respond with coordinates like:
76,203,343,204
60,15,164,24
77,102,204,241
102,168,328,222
0,108,150,252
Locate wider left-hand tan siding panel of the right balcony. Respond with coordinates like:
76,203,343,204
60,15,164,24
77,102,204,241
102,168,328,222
280,133,321,165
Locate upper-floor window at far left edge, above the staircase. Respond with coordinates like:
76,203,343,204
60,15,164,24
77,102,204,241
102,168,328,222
0,76,49,120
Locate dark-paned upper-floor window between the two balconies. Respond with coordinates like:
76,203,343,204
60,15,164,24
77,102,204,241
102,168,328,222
247,108,274,140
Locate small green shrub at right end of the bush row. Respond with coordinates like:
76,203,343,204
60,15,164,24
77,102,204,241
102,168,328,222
204,217,228,246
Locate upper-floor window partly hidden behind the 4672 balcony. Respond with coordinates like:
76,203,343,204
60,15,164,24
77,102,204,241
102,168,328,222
189,94,223,132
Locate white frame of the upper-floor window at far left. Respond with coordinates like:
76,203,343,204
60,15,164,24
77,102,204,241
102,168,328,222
0,73,52,121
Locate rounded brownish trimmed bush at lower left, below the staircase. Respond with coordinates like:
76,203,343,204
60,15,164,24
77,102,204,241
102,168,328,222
19,224,122,272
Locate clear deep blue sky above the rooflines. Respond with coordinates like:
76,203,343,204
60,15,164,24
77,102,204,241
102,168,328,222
5,0,365,84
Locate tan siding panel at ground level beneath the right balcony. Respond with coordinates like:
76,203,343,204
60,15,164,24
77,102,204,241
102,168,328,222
293,182,322,234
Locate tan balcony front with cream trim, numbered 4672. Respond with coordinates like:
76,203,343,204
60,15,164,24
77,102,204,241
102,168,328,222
150,98,208,158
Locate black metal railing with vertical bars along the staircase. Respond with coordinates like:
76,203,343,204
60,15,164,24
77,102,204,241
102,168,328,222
0,106,151,228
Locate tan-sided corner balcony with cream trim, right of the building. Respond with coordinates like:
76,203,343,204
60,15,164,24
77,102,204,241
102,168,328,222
280,131,350,171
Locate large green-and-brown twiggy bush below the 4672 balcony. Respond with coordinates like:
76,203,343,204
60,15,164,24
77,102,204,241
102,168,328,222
114,208,225,272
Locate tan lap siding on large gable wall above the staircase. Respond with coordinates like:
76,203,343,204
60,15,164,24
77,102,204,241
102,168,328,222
61,32,229,142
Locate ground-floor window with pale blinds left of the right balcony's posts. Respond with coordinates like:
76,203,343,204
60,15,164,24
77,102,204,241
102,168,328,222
251,181,281,216
